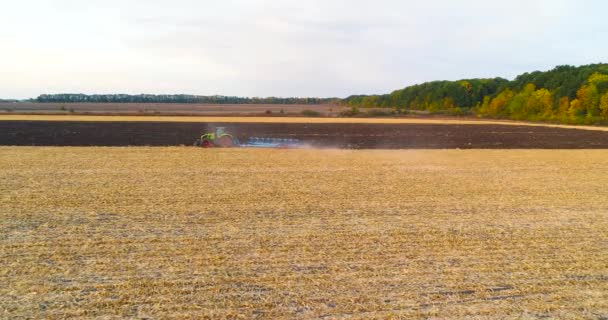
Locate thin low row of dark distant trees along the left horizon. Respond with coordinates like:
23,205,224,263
35,93,337,104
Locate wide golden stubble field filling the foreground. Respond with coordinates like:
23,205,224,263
0,147,608,319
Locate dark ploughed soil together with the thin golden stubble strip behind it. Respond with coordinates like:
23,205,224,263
0,115,608,149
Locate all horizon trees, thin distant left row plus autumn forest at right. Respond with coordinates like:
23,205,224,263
26,64,608,124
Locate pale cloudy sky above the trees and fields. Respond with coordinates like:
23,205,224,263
0,0,608,98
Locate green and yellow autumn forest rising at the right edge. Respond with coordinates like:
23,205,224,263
342,64,608,124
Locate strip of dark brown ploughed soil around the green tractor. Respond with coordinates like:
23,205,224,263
0,121,608,149
